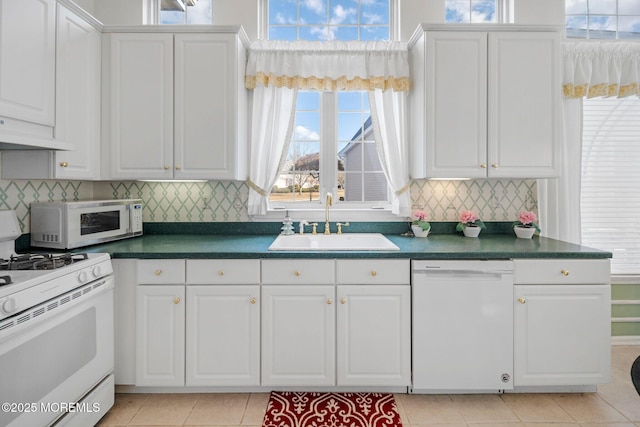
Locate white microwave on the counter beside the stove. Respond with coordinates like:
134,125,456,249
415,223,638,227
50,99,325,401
31,199,142,249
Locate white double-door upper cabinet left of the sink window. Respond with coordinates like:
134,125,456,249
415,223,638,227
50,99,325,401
103,30,247,180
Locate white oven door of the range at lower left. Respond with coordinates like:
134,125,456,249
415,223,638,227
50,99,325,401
0,276,114,426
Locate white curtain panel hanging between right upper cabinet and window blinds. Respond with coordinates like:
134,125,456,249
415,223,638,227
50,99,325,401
537,99,582,244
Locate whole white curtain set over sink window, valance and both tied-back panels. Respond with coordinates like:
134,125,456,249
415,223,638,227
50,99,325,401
245,40,410,216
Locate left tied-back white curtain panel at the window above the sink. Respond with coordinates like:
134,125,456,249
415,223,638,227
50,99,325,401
247,86,298,215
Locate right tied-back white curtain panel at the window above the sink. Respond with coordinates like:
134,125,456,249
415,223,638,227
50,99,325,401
369,89,411,216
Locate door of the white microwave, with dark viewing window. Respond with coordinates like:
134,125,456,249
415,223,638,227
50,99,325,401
66,204,130,248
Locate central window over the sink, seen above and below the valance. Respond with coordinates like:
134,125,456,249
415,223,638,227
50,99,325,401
256,0,396,218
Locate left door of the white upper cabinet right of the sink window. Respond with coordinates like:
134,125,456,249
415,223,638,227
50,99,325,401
425,31,487,178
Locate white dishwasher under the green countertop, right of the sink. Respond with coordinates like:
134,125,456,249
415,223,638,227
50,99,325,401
411,260,513,393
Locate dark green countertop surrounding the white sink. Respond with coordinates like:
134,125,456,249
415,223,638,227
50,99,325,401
82,233,612,259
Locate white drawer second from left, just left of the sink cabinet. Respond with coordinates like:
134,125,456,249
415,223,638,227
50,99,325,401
187,259,260,285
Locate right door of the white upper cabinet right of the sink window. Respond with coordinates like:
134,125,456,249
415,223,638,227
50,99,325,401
489,32,562,178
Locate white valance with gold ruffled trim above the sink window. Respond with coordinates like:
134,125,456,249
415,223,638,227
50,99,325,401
245,40,410,92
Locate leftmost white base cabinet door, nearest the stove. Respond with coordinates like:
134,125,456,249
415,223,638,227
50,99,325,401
136,285,185,386
